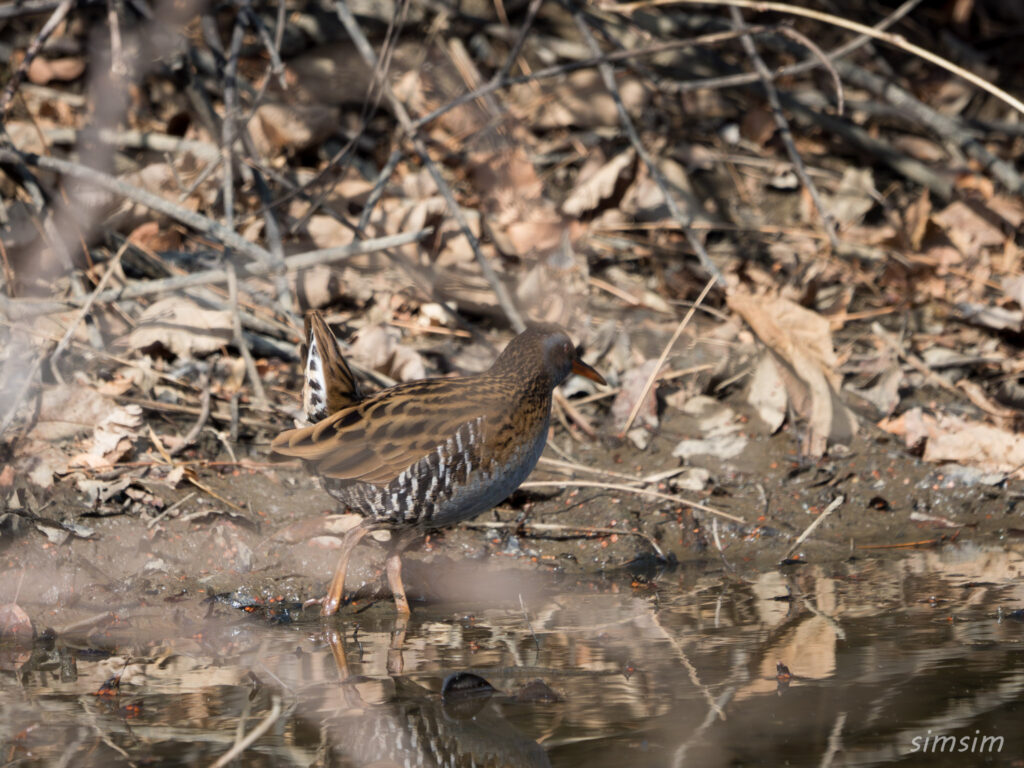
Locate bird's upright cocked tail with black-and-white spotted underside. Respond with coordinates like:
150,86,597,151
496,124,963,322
302,310,362,423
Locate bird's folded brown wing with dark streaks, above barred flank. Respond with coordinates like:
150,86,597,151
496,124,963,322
270,379,494,486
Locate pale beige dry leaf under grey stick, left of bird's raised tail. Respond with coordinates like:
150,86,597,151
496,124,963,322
128,298,234,357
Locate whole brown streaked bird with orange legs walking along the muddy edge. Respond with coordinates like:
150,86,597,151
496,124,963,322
271,312,604,615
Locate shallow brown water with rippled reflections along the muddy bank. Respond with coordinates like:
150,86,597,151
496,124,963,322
0,546,1024,766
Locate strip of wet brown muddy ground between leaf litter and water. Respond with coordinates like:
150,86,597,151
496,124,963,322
3,397,1024,632
